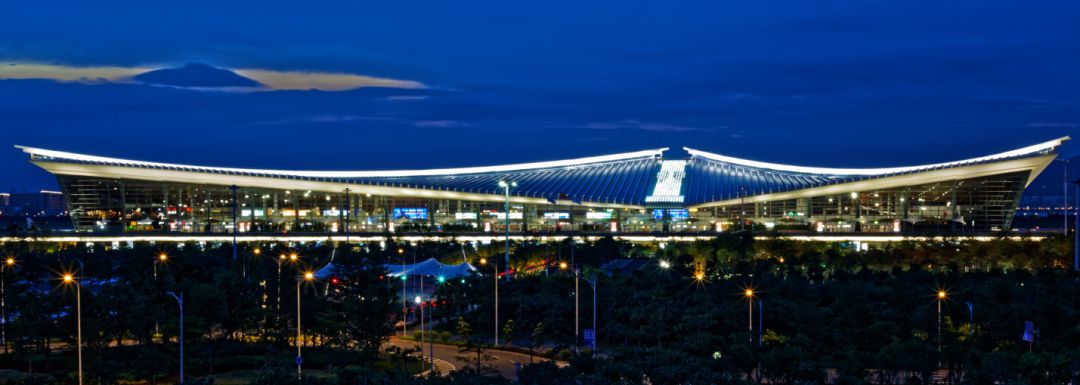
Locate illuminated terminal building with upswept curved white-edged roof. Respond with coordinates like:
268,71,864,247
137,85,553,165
12,137,1068,235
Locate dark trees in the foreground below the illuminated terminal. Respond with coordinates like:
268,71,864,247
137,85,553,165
0,234,1080,385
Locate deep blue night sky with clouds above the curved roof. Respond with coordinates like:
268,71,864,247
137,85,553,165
0,0,1080,190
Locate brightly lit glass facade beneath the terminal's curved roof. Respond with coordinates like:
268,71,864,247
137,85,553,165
57,171,1029,234
